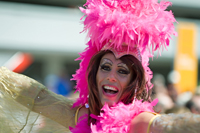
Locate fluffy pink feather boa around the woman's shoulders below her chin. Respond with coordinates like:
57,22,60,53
70,99,158,133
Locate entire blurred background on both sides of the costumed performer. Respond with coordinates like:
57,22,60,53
0,0,200,113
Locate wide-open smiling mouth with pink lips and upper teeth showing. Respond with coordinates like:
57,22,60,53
102,85,119,96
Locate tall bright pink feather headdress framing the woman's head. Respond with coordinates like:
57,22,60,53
73,0,177,106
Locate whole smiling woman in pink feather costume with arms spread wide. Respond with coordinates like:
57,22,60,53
0,0,200,133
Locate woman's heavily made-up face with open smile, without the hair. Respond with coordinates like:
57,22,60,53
96,53,131,106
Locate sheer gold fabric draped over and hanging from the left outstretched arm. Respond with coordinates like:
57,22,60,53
0,67,77,133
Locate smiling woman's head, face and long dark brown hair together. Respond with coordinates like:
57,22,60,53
88,49,150,124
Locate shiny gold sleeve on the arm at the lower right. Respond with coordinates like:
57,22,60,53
150,113,200,133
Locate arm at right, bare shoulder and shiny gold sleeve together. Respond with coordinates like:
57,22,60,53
129,112,200,133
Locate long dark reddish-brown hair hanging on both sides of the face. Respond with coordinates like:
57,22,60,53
87,50,150,124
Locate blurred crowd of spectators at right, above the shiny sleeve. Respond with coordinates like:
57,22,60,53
152,74,200,114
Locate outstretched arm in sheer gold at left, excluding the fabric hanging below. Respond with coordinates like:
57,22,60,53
0,67,76,128
